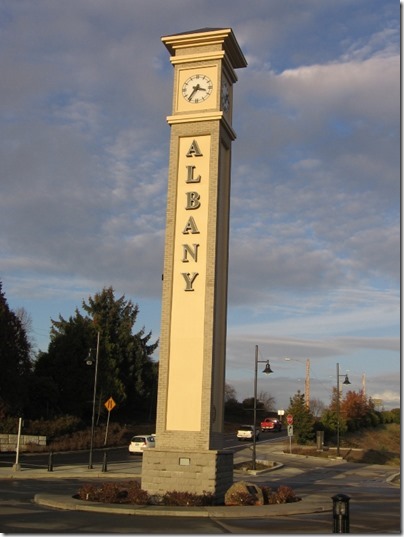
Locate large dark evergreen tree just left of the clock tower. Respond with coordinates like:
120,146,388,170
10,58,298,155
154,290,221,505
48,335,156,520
35,287,158,417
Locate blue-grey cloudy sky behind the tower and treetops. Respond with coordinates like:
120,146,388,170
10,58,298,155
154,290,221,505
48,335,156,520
0,0,400,408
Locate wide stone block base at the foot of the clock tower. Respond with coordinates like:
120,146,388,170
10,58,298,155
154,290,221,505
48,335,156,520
141,448,233,504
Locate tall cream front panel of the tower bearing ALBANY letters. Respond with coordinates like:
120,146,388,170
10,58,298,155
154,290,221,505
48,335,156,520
167,135,211,431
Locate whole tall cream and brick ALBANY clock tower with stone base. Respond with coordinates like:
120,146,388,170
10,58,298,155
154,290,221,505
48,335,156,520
142,28,247,502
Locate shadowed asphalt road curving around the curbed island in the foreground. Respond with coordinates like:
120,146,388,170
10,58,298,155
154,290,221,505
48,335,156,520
0,444,401,534
